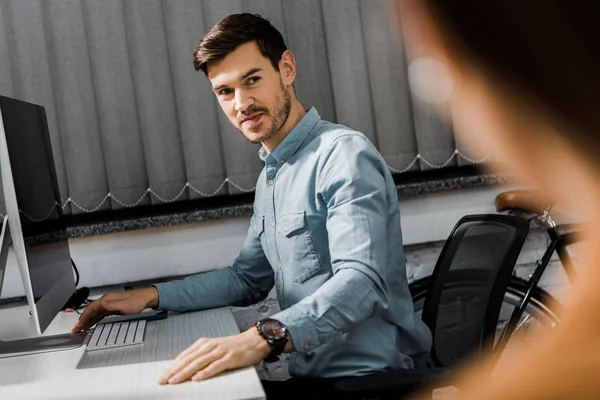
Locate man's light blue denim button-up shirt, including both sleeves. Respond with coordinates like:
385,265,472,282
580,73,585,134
156,108,431,377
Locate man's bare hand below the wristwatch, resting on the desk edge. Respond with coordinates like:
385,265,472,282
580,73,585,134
158,326,271,385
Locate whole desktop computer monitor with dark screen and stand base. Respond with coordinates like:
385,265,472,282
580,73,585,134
0,96,86,357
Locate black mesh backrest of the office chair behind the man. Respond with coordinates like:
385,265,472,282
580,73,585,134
422,215,529,369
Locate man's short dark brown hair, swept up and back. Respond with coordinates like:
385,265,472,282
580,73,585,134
194,13,287,74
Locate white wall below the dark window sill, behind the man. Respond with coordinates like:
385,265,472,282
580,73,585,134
0,188,506,298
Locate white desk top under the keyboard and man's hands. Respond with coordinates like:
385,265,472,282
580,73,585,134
0,306,265,400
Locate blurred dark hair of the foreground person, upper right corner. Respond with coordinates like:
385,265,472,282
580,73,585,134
417,0,600,161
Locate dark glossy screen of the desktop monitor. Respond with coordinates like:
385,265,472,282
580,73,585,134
0,96,72,306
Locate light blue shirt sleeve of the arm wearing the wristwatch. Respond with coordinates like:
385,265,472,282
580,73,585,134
273,134,394,351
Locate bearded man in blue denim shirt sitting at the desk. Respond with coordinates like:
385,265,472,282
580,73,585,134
73,14,431,394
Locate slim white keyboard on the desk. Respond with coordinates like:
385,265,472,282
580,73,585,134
85,320,146,351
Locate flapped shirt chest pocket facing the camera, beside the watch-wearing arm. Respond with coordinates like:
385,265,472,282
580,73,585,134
277,212,321,283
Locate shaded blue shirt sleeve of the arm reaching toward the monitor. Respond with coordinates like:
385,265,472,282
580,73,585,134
154,215,274,311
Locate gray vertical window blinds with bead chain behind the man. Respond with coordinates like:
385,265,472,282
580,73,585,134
0,0,485,219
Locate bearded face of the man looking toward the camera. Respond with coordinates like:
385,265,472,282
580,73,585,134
207,42,292,143
